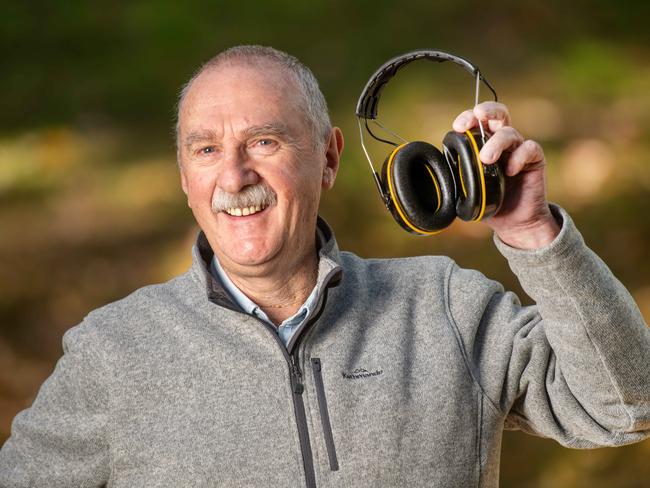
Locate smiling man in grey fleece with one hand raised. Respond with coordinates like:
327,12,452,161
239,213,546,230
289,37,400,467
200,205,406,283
0,46,650,488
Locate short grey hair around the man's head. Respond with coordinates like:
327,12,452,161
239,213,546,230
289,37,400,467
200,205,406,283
176,46,332,154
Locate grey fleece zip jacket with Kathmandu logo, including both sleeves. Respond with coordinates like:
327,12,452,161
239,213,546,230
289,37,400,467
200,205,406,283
0,209,650,488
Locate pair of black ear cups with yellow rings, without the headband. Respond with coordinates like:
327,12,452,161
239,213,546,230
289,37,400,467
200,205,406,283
381,131,505,235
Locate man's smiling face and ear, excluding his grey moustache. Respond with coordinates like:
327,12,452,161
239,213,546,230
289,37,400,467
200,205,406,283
179,61,340,276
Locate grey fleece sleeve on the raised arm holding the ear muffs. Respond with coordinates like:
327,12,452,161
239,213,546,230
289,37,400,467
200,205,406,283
449,206,650,447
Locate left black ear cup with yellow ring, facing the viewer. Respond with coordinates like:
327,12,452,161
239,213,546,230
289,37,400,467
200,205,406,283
381,141,456,235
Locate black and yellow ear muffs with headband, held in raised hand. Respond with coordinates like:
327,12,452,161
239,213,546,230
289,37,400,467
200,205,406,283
355,49,505,235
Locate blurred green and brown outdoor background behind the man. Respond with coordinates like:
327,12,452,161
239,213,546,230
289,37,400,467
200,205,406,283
0,0,650,488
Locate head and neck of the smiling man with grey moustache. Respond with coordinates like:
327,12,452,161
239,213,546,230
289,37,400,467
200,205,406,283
177,51,343,327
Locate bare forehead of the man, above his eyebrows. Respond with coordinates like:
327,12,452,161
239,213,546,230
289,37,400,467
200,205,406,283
179,61,302,136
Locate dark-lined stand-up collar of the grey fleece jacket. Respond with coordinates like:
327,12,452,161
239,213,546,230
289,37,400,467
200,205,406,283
190,216,343,312
